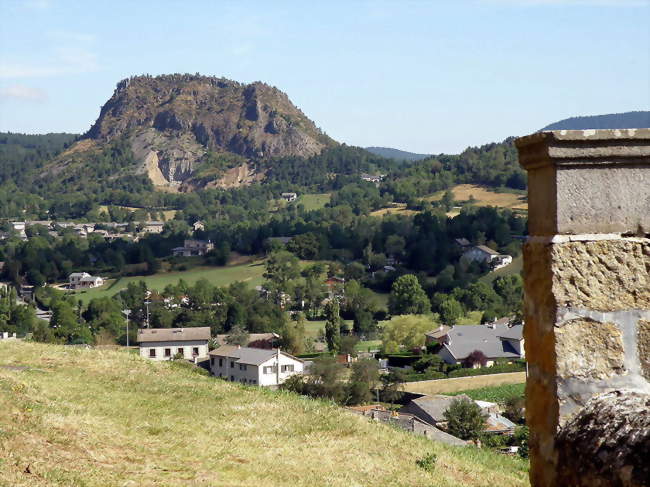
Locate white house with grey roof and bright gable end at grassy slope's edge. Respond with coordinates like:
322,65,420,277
210,345,304,387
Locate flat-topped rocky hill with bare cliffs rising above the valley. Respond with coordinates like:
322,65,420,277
43,74,337,191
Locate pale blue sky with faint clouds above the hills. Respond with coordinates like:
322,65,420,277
0,0,650,154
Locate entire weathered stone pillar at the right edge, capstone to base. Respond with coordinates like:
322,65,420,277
516,129,650,487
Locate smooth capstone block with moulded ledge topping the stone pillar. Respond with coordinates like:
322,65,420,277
516,129,650,235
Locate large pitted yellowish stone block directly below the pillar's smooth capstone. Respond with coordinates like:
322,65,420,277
551,239,650,311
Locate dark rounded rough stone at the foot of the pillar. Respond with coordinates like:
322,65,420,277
554,391,650,487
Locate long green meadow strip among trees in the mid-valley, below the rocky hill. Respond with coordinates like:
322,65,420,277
77,261,264,303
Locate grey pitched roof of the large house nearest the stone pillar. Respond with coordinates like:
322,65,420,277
443,323,523,360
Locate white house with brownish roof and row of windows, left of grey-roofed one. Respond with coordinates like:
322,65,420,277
138,326,210,360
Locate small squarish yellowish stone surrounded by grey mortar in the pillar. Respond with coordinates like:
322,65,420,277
555,319,625,381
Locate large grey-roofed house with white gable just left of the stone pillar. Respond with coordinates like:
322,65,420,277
438,319,526,367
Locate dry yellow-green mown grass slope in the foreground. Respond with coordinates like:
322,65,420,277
0,341,528,487
